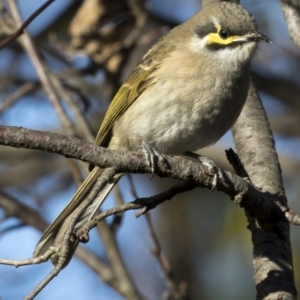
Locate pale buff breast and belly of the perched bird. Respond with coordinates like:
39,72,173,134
114,62,249,155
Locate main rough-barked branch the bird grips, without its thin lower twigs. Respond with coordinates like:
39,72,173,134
0,126,300,227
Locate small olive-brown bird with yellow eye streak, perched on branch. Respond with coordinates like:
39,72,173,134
34,2,271,264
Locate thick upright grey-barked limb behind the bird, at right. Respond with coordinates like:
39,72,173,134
233,85,296,300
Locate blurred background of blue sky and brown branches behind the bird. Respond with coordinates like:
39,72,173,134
0,0,300,300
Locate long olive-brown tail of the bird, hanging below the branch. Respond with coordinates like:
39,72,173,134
33,167,121,264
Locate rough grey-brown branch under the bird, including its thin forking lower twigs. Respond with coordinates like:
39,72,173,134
0,126,300,299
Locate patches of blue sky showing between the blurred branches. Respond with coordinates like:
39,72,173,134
0,0,300,300
